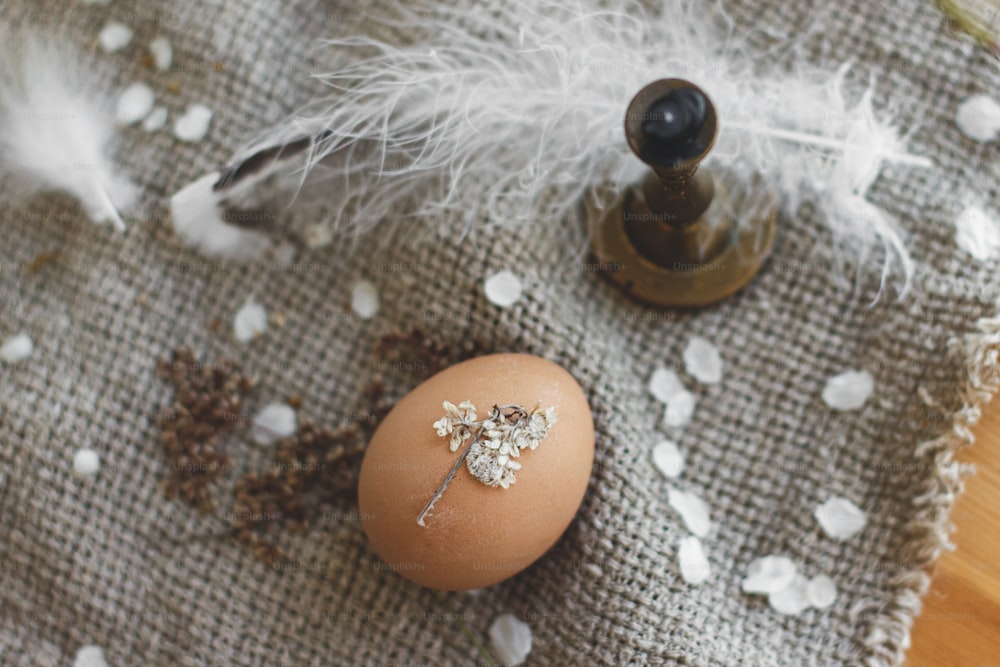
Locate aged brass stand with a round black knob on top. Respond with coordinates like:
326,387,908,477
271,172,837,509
585,79,777,307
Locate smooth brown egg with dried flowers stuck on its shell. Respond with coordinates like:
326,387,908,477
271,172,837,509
358,354,594,590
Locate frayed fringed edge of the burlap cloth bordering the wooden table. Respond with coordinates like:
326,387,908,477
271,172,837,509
859,313,1000,667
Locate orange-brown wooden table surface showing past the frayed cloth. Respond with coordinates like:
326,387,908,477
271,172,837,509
906,400,1000,667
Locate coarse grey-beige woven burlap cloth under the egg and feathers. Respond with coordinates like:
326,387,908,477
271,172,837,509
0,0,1000,667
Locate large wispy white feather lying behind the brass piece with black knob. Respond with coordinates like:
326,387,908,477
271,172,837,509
174,0,930,291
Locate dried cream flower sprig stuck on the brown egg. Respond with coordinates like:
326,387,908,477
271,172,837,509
417,401,556,527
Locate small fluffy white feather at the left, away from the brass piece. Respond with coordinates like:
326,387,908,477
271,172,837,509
0,29,138,229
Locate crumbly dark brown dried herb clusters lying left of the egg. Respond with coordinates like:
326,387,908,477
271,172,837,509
157,328,490,564
